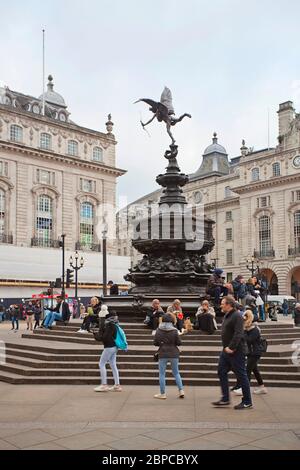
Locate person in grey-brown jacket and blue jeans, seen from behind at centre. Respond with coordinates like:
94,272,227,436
154,314,184,400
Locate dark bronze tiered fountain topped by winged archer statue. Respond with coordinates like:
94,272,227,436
107,88,214,313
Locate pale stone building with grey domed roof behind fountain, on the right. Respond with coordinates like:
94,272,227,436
118,101,300,298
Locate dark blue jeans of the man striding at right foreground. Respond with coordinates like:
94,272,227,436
218,351,252,405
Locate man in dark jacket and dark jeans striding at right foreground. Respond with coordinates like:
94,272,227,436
212,295,252,410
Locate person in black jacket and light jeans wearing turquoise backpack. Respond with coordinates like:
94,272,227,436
94,311,122,392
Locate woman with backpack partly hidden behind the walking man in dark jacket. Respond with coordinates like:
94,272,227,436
232,310,268,395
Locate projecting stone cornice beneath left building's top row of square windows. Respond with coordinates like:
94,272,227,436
0,140,127,176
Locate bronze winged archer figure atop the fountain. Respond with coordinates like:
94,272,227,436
135,87,192,145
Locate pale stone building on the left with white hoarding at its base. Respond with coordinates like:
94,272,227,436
0,76,129,297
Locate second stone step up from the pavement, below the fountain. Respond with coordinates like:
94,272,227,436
0,364,300,386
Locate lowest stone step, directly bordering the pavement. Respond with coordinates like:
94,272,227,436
0,371,299,389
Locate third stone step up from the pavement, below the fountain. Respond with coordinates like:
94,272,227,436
5,355,300,373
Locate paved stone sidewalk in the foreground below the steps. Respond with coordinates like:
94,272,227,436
0,383,300,450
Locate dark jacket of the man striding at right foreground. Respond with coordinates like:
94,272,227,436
221,310,247,354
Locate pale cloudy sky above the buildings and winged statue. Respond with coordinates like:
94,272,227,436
0,0,300,207
